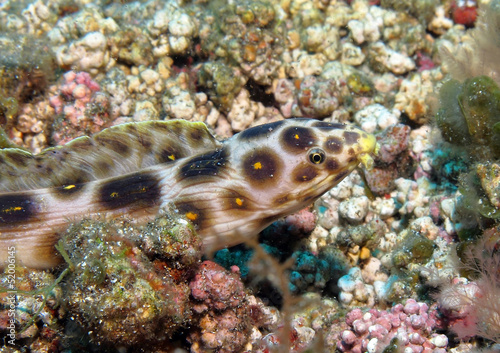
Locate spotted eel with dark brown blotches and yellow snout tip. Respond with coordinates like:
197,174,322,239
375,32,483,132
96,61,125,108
0,119,377,269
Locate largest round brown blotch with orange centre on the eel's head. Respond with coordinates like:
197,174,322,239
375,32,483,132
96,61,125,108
243,148,281,186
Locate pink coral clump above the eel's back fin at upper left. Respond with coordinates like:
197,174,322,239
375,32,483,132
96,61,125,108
49,71,111,144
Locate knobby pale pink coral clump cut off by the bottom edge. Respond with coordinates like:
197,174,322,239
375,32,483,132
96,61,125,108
337,299,448,353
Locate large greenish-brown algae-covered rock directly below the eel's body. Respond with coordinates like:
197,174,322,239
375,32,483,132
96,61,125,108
62,215,201,346
